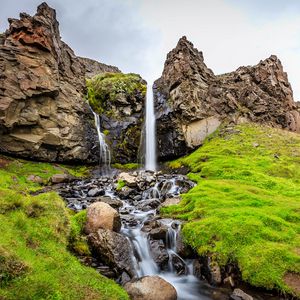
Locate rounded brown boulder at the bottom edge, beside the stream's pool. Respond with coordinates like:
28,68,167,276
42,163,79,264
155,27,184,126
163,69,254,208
124,276,177,300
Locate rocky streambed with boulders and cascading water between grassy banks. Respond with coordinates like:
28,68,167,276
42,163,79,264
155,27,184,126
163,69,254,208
58,171,279,300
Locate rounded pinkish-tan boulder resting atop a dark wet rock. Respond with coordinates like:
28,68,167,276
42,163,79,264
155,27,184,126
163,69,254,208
85,202,121,234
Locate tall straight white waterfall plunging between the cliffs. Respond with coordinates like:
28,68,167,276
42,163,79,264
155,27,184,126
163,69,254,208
145,84,156,171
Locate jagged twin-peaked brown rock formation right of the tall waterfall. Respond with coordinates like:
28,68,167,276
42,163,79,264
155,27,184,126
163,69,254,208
153,37,300,159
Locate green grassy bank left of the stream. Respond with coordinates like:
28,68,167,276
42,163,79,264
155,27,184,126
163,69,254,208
0,157,128,300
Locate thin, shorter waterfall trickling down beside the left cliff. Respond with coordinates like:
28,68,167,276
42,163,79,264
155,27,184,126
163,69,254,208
91,108,111,173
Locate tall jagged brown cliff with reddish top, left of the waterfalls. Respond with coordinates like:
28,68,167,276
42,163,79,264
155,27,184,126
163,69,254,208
0,3,98,162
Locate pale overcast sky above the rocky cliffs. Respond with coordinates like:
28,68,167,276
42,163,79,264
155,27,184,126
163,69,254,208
0,0,300,100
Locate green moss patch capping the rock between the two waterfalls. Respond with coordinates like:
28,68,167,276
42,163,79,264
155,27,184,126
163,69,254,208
87,73,147,115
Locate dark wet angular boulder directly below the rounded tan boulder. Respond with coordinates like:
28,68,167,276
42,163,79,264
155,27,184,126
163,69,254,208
88,229,135,278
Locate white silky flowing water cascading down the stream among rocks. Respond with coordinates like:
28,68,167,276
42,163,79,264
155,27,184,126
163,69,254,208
120,178,212,300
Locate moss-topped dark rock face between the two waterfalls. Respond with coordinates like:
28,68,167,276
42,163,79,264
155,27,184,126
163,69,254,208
88,73,146,163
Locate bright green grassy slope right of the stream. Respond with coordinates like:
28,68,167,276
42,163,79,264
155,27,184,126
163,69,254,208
162,124,300,293
